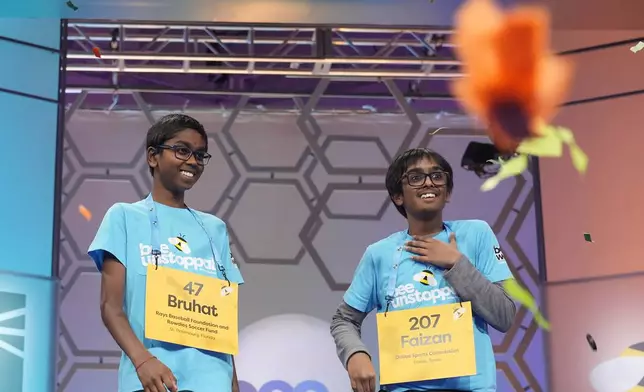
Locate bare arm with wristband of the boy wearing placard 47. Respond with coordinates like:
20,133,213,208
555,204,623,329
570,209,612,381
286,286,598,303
101,253,177,392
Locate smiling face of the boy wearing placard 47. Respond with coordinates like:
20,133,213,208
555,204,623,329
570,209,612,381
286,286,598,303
148,129,207,194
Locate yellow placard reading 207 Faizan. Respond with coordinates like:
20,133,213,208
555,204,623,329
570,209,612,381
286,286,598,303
377,302,476,385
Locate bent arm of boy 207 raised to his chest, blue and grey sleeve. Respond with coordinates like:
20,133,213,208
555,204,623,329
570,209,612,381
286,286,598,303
444,221,516,332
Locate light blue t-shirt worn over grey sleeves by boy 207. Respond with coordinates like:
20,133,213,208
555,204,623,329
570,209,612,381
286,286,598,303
344,220,512,392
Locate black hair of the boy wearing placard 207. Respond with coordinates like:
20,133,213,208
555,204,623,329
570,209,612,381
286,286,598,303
385,148,454,218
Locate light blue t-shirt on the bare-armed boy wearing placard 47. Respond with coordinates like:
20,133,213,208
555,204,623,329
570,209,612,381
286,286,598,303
88,201,243,392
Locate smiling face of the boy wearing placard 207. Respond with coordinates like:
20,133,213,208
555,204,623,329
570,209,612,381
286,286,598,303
392,158,450,219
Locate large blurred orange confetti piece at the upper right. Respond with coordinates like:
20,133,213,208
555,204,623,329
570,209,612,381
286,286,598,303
450,0,573,153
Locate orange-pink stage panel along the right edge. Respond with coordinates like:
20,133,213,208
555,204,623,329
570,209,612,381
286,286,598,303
540,30,644,392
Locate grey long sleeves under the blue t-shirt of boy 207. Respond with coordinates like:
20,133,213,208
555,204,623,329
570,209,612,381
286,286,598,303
331,256,516,368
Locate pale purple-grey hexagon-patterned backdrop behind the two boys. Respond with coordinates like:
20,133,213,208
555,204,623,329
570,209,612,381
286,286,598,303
58,105,547,392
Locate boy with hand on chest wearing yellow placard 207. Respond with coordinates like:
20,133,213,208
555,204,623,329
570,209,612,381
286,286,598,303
331,148,516,392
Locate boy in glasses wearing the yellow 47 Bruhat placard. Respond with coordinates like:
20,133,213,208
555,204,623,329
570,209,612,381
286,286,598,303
88,114,243,392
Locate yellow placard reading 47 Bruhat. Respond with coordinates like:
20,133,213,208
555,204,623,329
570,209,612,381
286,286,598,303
145,264,239,355
